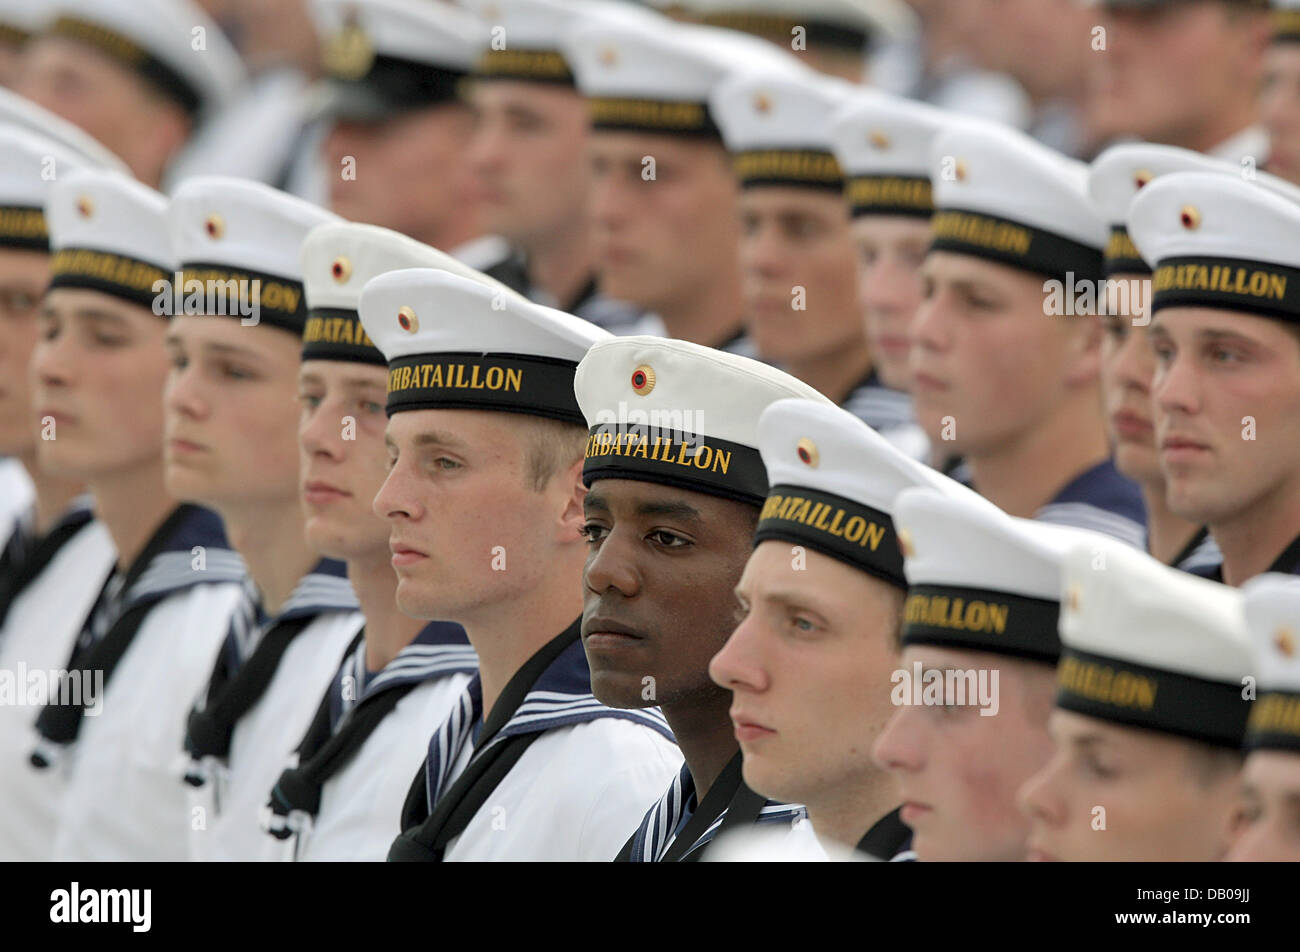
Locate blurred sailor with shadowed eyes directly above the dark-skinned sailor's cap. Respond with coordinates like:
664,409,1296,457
711,66,928,455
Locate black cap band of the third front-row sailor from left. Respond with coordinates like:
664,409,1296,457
176,261,307,336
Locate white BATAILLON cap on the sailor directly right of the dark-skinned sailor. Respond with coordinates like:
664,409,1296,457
754,401,992,589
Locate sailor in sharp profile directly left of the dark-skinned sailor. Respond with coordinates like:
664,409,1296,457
359,269,681,861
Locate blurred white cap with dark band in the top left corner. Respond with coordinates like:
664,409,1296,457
46,0,244,114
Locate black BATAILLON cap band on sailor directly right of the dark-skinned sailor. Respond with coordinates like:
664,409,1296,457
754,485,907,588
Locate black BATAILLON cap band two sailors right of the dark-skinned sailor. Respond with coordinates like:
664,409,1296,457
902,585,1061,665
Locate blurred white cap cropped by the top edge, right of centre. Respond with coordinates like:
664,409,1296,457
684,0,918,53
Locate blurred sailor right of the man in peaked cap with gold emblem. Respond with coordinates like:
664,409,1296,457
468,0,641,333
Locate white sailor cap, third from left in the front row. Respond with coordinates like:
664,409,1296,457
168,176,342,336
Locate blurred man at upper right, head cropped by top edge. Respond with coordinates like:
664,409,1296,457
1084,0,1270,168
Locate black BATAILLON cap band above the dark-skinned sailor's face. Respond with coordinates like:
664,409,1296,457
582,423,767,506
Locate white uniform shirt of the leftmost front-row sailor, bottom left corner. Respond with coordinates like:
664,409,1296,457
0,522,116,862
